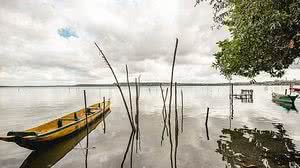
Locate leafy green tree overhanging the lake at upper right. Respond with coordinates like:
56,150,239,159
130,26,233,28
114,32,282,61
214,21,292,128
196,0,300,78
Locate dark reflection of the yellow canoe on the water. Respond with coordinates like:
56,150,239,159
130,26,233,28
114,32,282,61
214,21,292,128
20,111,110,168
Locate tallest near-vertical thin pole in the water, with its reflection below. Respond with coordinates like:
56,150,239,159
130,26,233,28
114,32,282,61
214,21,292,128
168,38,178,168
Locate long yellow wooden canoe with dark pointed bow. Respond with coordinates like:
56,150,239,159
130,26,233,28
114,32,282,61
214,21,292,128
0,101,111,150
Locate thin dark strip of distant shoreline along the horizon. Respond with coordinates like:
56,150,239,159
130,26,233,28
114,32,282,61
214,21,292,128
0,81,300,88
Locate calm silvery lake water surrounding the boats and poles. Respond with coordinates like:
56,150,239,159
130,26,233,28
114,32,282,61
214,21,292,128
0,86,300,168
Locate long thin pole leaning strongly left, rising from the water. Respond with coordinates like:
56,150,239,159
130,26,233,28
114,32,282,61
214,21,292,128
95,42,135,131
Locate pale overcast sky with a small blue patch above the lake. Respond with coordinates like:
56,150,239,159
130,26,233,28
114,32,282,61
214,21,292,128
0,0,299,85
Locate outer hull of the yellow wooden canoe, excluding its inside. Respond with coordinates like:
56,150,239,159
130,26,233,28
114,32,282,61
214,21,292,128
0,102,111,150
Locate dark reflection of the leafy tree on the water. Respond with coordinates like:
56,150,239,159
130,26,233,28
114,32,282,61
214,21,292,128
216,124,300,168
